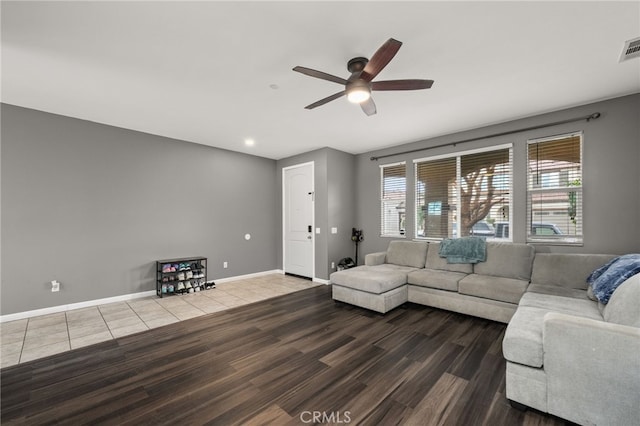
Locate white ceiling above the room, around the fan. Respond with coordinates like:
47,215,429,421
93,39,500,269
1,1,640,159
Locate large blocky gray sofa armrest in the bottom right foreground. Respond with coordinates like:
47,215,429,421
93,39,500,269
542,312,640,425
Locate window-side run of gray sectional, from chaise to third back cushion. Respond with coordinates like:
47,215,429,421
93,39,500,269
330,240,535,323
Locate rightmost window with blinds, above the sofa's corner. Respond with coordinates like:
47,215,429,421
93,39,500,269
527,133,583,244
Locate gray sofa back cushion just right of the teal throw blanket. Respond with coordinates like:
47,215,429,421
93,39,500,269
473,241,535,282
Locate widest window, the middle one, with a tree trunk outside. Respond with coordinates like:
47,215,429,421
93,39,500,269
415,145,513,239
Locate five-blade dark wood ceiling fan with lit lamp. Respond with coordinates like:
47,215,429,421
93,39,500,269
293,38,433,115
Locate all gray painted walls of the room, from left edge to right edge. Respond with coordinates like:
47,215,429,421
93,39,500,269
0,95,640,315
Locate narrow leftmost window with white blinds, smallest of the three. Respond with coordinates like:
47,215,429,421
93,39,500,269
380,162,407,237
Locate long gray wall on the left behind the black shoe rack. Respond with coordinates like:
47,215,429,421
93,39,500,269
0,104,280,315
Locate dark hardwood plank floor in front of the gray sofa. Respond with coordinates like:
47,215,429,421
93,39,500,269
1,286,563,426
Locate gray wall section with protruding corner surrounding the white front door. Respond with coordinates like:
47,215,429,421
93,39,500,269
277,148,356,280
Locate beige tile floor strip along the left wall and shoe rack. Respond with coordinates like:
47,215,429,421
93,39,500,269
0,274,318,368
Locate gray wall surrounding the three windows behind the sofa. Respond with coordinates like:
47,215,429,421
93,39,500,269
356,94,640,254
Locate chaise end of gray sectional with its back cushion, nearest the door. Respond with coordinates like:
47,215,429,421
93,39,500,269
330,241,429,314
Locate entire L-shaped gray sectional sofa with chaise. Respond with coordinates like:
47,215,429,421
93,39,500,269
331,240,640,425
